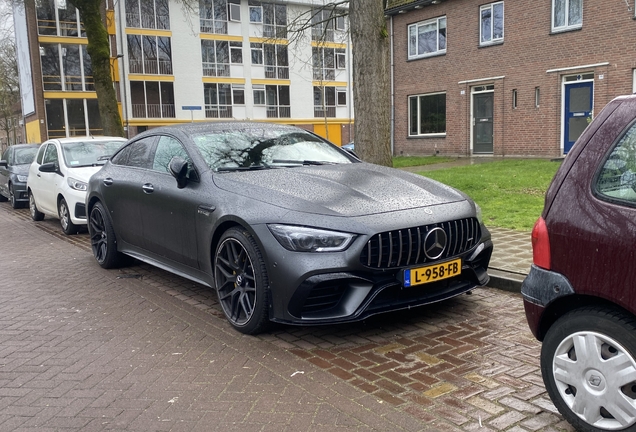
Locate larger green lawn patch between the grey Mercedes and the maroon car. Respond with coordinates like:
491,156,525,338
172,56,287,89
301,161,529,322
418,159,560,230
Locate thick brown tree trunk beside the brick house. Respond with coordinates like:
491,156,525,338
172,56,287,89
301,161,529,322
349,0,393,166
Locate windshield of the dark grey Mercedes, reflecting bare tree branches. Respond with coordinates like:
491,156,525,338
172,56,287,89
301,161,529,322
192,127,351,171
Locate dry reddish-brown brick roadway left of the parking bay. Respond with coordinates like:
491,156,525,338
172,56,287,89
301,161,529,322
0,207,420,431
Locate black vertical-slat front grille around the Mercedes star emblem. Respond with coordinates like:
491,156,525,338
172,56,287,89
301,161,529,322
360,218,481,269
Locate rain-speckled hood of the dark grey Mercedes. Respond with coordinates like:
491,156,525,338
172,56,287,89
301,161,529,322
214,163,466,217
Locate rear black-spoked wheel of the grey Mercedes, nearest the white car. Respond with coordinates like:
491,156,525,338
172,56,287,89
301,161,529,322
88,202,122,269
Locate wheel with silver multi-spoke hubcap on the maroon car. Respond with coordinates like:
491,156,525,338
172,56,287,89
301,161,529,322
541,308,636,431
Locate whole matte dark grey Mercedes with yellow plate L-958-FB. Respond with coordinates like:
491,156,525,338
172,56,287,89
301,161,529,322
86,122,492,334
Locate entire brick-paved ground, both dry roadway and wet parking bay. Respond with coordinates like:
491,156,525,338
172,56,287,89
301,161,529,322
0,203,572,432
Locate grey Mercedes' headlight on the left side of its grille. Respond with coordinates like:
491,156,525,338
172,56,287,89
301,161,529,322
267,224,355,252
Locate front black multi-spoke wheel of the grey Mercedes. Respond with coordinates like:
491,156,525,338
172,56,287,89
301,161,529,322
214,228,269,334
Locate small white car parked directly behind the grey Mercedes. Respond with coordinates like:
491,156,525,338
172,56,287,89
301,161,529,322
27,136,126,234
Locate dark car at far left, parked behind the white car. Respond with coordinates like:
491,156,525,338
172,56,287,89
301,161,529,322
0,144,39,208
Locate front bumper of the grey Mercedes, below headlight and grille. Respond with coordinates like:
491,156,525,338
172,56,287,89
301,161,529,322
261,223,493,325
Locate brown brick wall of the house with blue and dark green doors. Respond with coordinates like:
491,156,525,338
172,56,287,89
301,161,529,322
392,0,636,157
